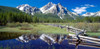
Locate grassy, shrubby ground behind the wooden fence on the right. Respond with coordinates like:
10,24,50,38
51,23,100,36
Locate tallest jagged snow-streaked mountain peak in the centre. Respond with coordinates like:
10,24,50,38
40,2,75,19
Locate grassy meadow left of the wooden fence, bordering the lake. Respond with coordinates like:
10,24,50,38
0,23,69,34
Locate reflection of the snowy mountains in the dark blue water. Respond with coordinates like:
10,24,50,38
16,34,67,45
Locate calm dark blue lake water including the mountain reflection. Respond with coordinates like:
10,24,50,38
0,34,100,49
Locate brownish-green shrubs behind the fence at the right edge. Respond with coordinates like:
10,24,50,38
75,23,100,32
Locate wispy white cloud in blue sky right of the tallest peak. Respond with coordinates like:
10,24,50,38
72,4,95,14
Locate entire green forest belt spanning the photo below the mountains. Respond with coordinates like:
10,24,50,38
0,12,100,25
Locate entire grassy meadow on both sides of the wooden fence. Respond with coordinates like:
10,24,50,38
0,23,100,36
